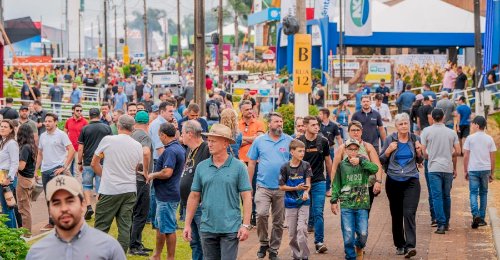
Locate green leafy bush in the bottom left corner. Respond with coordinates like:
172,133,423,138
0,214,29,259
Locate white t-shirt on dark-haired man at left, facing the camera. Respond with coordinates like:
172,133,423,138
38,128,71,172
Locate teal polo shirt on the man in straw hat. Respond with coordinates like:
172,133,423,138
191,156,252,233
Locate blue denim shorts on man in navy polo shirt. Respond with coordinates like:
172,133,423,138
155,200,179,234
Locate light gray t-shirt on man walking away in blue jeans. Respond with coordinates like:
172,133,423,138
420,124,458,173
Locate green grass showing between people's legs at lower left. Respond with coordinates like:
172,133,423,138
29,219,191,260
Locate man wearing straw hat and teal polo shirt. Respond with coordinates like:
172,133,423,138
184,124,252,259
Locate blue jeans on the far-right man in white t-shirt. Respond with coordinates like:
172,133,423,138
469,171,491,219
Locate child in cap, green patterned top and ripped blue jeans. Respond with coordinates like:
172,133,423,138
330,138,378,260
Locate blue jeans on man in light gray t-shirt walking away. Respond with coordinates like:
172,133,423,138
429,172,453,227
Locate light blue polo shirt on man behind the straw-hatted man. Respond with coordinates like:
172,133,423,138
247,133,292,189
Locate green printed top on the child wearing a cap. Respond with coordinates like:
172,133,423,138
331,158,378,209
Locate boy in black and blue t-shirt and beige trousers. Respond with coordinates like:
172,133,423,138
279,139,312,259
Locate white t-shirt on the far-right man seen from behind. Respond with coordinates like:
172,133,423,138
464,131,497,171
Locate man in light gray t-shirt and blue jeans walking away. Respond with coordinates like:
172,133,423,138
420,108,460,234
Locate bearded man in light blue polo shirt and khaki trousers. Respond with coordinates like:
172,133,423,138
248,112,292,260
